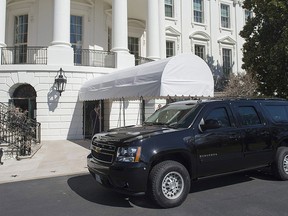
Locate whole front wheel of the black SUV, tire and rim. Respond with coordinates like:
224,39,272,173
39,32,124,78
148,161,191,208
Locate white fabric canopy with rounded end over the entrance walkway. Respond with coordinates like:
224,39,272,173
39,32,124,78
79,54,214,101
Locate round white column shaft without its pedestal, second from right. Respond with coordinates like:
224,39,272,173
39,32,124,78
111,0,128,52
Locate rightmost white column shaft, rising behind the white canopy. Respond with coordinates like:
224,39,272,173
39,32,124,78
147,0,160,60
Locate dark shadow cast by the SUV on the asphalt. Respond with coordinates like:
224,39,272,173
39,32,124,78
67,171,275,209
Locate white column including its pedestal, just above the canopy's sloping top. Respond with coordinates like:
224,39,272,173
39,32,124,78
111,0,135,68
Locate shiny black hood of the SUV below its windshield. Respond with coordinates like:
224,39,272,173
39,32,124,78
93,125,175,143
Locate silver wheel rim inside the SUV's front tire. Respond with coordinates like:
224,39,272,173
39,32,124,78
162,172,184,199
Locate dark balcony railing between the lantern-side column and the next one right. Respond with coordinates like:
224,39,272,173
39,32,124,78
74,49,116,68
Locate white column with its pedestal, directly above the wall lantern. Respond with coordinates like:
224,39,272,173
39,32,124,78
47,0,74,65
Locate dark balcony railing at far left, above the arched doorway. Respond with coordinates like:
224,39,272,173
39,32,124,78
1,45,47,65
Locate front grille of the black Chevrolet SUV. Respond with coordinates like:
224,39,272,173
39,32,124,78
91,141,116,163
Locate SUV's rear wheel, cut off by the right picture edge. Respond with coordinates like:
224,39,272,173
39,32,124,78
272,147,288,181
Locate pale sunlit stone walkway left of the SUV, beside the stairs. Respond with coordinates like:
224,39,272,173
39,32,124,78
0,140,90,184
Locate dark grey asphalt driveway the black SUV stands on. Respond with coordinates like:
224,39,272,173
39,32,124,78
0,171,288,216
